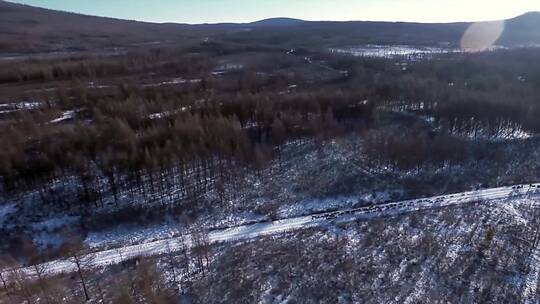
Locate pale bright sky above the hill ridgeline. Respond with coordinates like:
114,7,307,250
6,0,540,23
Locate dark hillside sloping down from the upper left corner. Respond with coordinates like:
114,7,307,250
0,1,216,53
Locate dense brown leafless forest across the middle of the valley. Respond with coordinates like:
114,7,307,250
0,43,540,247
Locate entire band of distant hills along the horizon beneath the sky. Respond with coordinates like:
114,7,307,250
0,0,540,53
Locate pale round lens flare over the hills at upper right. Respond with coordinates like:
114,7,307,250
461,21,504,52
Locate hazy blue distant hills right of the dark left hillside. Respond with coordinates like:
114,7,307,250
221,12,540,47
